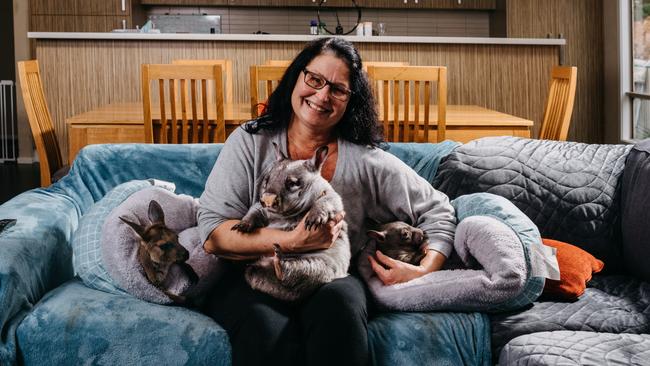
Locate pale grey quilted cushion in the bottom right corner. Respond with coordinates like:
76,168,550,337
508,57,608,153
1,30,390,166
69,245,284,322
499,331,650,366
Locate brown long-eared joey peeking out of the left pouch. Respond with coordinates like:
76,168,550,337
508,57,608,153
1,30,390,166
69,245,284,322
120,200,199,303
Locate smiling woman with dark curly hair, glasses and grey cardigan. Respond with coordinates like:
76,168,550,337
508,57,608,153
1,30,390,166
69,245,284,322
198,38,456,365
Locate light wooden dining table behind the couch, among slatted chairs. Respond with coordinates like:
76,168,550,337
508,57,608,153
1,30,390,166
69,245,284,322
66,102,533,164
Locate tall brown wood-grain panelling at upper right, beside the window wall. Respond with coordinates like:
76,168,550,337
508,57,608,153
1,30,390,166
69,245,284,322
506,0,604,143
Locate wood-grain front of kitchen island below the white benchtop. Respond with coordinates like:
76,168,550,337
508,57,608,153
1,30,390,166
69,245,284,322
36,40,558,156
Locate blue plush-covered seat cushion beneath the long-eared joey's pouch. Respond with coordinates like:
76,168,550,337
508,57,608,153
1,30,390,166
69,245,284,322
17,279,231,366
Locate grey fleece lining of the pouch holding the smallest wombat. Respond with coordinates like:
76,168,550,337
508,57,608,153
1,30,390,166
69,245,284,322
359,216,543,312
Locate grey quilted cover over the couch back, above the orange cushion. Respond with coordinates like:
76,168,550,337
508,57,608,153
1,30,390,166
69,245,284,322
433,137,632,271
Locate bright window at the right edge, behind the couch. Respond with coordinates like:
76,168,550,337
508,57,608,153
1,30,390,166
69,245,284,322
623,0,650,140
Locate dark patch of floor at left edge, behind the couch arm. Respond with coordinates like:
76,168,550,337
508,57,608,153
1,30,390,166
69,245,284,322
0,162,41,204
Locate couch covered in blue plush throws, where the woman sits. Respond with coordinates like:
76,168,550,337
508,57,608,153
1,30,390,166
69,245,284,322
0,143,490,365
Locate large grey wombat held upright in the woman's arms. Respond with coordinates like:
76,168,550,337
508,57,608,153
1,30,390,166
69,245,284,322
232,143,350,301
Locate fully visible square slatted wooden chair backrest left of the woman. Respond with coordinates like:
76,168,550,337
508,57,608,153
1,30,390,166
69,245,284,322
142,64,226,144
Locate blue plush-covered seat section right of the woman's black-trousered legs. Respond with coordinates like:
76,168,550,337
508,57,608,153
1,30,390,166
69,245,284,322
368,313,491,366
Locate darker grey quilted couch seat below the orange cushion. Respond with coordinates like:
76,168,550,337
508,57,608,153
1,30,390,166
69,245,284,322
490,275,650,351
